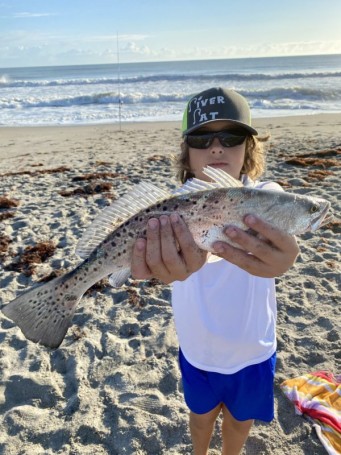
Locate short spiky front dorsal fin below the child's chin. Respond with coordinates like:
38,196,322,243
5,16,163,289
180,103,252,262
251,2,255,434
174,166,243,195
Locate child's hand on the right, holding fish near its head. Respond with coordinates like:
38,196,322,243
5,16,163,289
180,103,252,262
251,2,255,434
214,215,299,278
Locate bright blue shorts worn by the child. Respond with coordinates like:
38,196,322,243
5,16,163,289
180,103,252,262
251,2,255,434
179,349,276,422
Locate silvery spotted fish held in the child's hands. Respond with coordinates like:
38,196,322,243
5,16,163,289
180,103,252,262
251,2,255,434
2,166,330,349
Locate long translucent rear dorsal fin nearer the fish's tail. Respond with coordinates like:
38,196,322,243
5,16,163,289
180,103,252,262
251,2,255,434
76,182,172,259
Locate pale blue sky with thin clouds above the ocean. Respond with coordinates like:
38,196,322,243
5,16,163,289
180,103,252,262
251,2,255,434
0,0,341,68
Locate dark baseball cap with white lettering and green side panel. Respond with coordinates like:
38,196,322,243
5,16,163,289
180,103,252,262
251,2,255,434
182,87,258,136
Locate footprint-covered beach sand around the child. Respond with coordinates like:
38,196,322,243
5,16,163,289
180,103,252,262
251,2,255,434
0,114,341,455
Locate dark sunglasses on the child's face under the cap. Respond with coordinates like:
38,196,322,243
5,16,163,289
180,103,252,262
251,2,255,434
185,131,249,149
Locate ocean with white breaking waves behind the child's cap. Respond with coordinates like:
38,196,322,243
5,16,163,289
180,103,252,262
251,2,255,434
0,55,341,126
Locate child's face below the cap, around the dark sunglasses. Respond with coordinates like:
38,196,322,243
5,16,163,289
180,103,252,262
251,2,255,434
189,121,246,181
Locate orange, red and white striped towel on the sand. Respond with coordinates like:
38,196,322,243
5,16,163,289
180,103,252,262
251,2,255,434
281,371,341,455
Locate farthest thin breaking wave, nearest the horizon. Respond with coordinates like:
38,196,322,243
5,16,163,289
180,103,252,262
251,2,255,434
0,71,341,88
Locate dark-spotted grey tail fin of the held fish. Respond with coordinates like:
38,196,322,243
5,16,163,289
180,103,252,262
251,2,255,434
2,272,84,348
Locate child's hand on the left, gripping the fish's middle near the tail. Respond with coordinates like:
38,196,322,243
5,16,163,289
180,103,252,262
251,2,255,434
131,213,207,284
